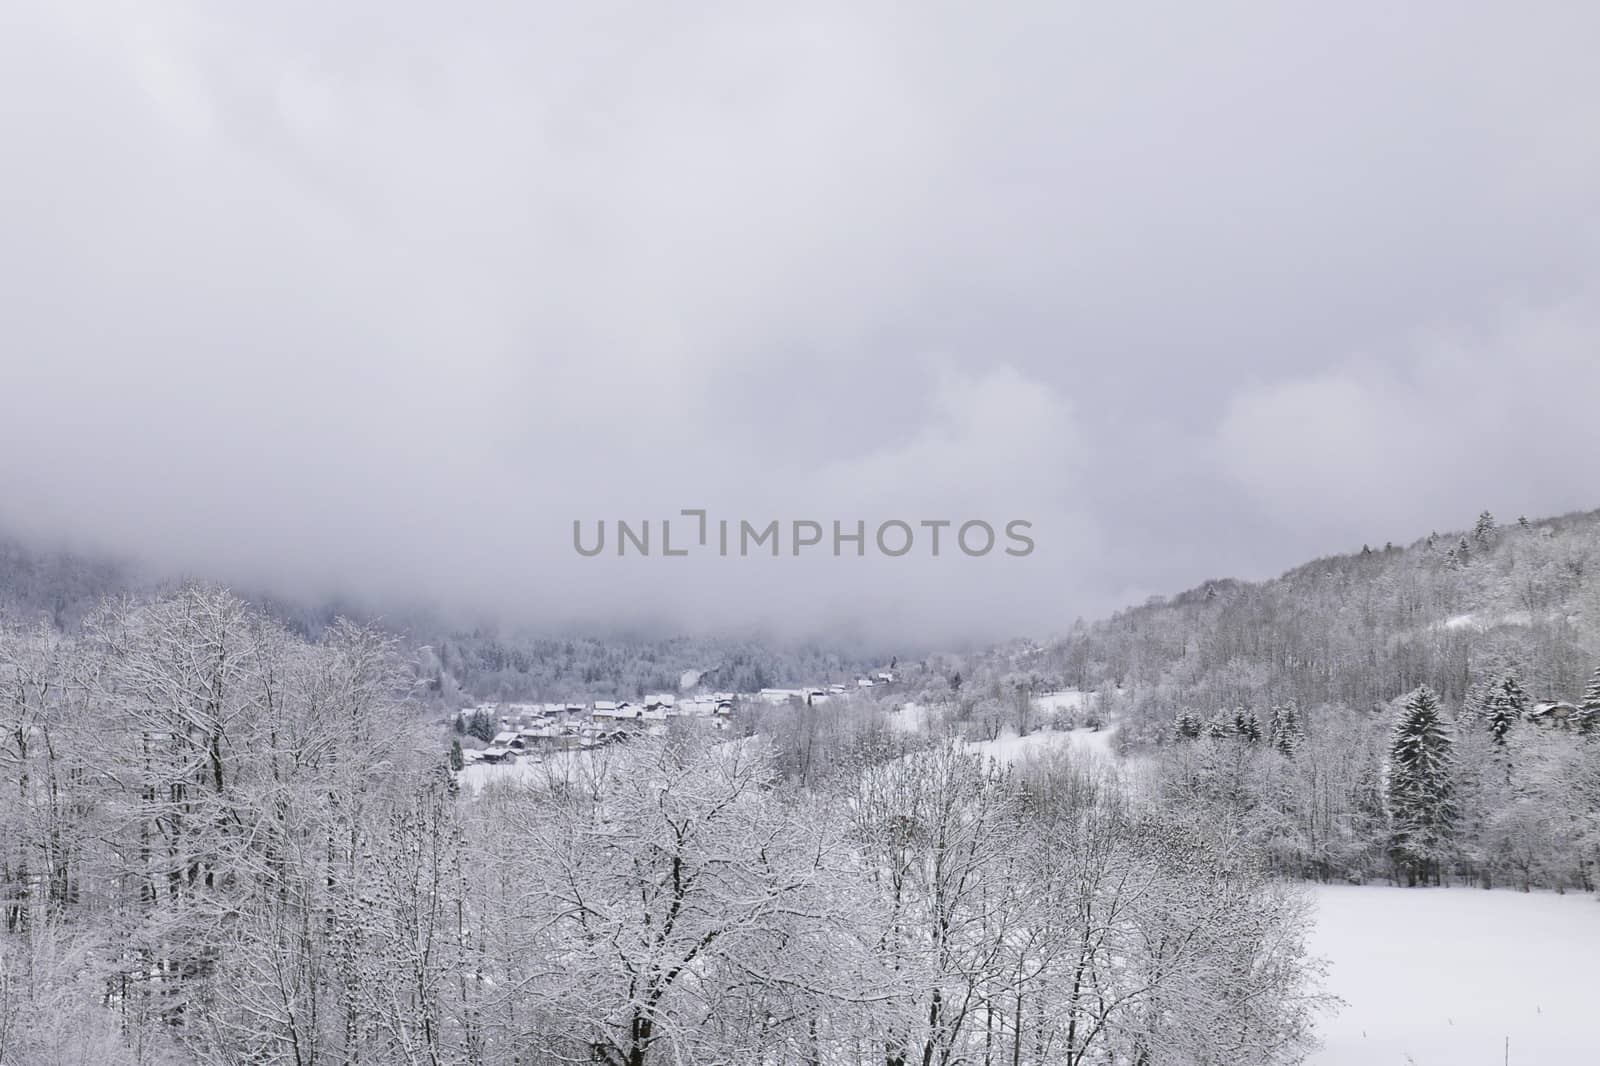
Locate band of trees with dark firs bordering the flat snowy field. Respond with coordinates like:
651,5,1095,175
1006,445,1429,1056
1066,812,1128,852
1142,674,1600,892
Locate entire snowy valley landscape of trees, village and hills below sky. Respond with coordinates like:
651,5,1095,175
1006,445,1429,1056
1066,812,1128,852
0,514,1600,1066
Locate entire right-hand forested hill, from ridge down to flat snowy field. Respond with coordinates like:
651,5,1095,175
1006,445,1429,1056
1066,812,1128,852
918,512,1600,890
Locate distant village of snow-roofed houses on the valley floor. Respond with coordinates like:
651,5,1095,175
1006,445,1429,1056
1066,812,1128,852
451,671,894,767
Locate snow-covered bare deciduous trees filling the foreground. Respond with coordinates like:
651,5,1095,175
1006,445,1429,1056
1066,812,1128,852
0,587,1317,1066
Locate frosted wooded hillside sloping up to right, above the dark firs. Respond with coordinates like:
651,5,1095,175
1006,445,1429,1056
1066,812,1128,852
1021,512,1600,723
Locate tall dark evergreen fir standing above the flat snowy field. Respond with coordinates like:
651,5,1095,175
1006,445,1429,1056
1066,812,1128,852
1386,685,1456,885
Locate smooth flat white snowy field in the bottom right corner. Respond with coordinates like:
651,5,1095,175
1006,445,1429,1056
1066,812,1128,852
1307,885,1600,1066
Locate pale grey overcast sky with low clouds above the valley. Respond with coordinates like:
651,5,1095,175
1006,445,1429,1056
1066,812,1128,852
0,0,1600,640
